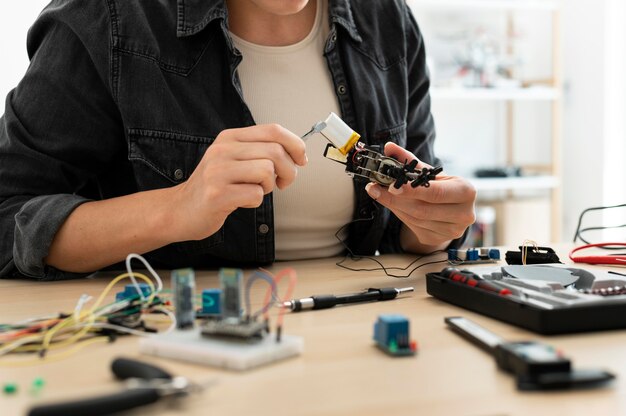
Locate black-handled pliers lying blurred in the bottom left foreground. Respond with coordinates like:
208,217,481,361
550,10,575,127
28,358,202,416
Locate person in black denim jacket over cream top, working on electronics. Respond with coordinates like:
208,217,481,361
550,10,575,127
0,0,476,280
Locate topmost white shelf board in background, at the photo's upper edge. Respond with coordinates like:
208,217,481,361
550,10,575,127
407,0,561,10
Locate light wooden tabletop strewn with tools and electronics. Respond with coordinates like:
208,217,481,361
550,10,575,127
0,250,626,415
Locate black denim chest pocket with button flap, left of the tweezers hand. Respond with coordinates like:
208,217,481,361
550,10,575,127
128,129,215,191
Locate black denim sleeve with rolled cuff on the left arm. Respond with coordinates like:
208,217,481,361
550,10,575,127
0,1,124,280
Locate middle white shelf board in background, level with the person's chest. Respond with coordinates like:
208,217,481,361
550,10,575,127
430,87,560,101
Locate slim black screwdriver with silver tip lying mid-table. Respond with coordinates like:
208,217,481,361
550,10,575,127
283,287,413,312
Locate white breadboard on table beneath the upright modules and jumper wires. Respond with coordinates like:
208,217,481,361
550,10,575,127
139,329,304,370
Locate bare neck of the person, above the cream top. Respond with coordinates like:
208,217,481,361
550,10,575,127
226,0,317,46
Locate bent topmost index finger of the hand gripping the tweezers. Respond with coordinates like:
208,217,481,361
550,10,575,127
220,124,307,166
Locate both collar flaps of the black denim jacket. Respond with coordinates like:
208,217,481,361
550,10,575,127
176,0,362,42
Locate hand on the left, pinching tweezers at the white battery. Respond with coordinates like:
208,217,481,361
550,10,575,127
171,124,307,241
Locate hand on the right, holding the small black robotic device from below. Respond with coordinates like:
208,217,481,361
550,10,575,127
365,142,476,253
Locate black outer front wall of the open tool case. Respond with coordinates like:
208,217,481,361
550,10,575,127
426,273,626,335
